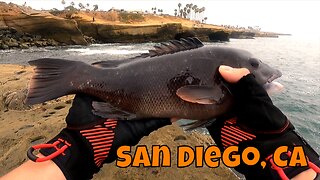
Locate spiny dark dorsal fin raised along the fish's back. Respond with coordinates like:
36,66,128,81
135,37,203,58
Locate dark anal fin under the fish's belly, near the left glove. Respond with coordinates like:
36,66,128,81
92,101,136,120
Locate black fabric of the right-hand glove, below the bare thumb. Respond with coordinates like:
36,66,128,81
207,74,294,148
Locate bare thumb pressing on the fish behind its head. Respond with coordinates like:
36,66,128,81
219,65,250,83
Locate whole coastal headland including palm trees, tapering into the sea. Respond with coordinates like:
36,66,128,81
0,1,284,49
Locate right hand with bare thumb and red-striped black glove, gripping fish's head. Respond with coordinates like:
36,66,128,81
207,66,320,179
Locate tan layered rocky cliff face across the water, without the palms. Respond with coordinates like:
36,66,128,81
0,3,228,49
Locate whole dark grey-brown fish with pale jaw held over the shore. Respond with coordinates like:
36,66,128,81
25,38,282,128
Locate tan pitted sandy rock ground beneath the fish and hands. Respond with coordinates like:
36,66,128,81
0,64,236,180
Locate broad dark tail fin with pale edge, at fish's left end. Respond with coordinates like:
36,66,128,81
25,58,84,105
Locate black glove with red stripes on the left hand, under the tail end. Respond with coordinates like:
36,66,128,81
40,95,171,179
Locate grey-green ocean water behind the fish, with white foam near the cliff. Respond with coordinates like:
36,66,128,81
0,36,320,153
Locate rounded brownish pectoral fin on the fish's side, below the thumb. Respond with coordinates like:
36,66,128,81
176,85,224,104
